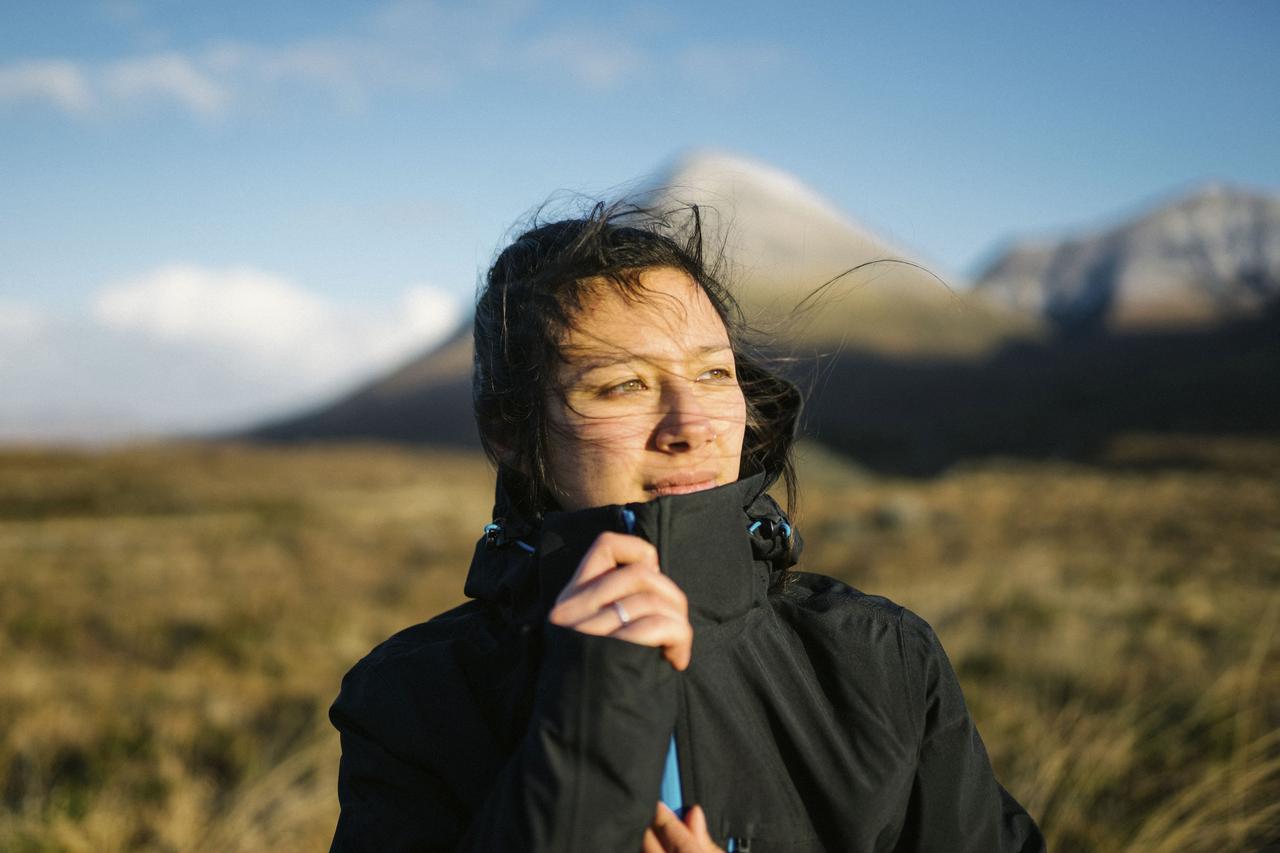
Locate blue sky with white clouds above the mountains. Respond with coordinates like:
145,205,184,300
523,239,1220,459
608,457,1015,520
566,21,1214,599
0,0,1280,435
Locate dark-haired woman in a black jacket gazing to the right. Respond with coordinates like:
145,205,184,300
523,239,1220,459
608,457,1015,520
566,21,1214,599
330,206,1043,853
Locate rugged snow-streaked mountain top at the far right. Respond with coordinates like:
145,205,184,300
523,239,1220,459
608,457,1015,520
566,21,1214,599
974,184,1280,333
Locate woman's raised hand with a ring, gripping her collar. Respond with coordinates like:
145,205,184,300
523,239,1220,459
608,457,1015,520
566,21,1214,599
548,533,694,670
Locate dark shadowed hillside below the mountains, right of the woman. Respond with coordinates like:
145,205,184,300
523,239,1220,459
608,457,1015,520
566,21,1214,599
797,300,1280,474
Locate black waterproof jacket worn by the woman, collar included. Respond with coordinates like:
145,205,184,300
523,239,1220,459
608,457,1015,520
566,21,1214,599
330,475,1043,853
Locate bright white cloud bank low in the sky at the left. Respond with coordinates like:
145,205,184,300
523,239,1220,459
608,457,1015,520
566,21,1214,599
0,264,460,441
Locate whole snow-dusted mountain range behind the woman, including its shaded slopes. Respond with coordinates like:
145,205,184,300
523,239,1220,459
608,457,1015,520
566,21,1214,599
251,154,1280,474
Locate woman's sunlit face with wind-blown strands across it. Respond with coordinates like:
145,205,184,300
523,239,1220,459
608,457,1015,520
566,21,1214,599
548,268,746,510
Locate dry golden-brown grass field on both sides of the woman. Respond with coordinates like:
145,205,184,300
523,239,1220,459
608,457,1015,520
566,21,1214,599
0,437,1280,853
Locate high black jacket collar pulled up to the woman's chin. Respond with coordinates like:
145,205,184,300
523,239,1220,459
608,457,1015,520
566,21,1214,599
466,469,800,626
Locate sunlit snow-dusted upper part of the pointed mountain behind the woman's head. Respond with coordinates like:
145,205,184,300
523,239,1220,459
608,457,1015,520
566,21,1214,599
637,151,1036,357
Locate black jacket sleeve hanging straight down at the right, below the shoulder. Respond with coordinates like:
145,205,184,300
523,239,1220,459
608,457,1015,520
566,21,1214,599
897,611,1044,853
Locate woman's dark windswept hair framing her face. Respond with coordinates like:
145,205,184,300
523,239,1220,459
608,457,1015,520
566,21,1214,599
472,202,800,514
